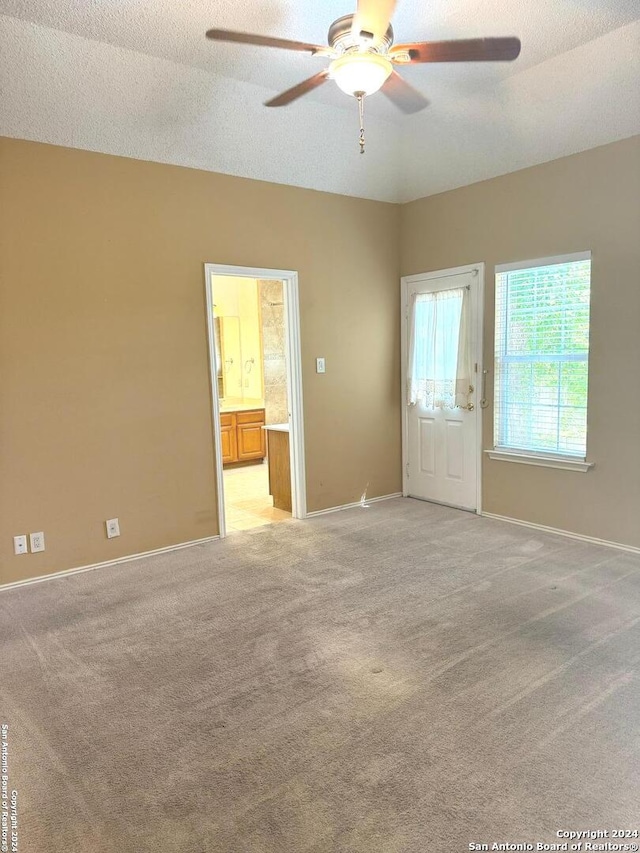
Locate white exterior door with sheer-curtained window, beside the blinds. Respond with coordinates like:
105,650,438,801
402,265,483,510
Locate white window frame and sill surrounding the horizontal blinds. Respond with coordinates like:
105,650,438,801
485,251,594,473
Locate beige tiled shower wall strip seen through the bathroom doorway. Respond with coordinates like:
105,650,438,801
258,281,289,424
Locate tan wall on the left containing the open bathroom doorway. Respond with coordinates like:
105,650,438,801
0,139,400,582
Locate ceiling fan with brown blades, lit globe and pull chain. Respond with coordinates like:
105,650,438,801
207,0,520,153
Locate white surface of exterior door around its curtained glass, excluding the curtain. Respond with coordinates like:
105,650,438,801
403,272,480,510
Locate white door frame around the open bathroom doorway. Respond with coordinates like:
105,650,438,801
204,263,307,539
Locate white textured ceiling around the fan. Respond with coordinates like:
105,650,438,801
0,0,640,201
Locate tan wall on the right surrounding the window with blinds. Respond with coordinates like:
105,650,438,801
401,137,640,546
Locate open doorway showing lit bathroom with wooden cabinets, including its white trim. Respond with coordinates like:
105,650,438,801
205,264,306,536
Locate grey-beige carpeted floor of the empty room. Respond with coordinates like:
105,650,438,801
0,499,640,853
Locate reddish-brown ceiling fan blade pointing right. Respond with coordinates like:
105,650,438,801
389,37,520,64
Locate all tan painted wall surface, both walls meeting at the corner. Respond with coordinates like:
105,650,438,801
0,138,640,583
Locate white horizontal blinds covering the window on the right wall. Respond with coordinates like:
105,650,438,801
494,258,591,459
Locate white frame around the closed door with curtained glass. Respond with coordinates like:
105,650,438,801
400,262,485,515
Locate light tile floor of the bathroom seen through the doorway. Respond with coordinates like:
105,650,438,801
223,461,291,533
